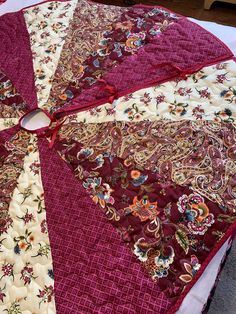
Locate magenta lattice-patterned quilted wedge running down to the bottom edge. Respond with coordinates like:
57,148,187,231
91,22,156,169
39,139,170,314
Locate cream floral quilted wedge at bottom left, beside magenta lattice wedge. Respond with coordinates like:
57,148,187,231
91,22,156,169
0,135,56,314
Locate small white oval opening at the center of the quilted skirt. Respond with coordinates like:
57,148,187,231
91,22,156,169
20,109,51,131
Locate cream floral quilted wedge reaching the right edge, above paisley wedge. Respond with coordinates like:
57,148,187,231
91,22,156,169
70,60,236,123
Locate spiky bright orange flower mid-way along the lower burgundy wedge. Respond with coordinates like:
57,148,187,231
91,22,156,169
124,196,159,221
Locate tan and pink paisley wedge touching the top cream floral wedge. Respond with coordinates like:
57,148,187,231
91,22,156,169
44,0,127,109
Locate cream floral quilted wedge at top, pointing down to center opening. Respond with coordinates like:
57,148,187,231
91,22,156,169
24,0,77,107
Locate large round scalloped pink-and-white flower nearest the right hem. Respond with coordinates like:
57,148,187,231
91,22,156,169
177,193,215,235
